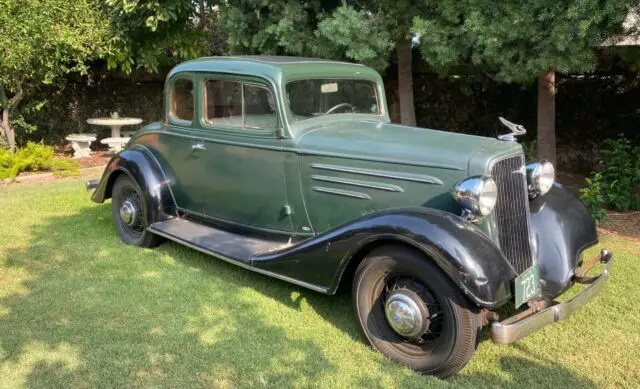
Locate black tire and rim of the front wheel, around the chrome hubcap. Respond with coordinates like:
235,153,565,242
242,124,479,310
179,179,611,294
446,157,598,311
352,245,481,378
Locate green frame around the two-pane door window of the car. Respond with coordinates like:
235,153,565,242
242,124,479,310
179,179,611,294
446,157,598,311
197,73,283,138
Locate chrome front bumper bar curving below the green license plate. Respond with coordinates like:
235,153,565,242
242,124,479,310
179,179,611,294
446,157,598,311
491,262,611,344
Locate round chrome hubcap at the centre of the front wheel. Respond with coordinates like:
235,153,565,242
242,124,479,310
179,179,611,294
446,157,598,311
384,289,429,338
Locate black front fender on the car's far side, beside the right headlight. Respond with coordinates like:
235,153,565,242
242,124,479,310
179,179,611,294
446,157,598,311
530,183,598,299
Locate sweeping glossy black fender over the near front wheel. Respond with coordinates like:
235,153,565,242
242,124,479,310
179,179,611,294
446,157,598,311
252,207,516,308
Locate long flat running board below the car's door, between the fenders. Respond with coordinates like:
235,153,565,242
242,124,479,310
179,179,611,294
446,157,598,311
148,218,287,265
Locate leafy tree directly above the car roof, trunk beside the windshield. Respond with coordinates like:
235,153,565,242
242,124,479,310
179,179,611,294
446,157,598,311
222,0,421,125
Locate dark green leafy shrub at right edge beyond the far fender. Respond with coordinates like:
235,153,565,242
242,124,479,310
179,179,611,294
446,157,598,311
580,135,640,219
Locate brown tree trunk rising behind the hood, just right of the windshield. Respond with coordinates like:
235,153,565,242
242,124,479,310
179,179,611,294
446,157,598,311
396,39,416,126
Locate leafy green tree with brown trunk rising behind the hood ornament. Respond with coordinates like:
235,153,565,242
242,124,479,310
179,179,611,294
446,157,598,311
413,0,638,161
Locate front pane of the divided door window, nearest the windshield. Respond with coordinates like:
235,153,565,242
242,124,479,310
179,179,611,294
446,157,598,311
244,84,278,129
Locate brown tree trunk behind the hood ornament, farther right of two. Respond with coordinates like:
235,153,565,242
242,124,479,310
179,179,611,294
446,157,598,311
538,68,556,165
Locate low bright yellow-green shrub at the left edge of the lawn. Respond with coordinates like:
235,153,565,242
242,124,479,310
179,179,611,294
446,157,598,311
0,142,78,180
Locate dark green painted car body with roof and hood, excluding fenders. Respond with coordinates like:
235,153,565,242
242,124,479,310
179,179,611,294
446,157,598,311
131,58,522,236
